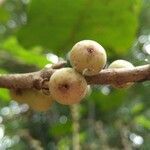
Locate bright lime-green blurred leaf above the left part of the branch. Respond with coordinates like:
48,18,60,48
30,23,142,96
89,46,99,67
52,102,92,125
0,37,50,68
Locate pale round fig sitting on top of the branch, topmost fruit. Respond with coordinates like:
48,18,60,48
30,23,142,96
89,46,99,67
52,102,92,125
69,40,107,76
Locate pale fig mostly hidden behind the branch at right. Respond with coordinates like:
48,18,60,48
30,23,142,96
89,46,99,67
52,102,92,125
108,59,134,88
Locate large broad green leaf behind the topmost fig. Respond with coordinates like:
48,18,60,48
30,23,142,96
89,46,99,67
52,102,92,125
17,0,141,55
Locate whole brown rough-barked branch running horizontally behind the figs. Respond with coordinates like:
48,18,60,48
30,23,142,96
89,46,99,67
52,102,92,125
0,62,150,89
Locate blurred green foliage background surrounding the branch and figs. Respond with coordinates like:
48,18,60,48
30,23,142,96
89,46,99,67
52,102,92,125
0,0,150,150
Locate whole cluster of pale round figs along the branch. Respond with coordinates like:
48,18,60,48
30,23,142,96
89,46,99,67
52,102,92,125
11,40,134,111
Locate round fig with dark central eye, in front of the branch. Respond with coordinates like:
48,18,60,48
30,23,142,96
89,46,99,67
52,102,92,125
49,68,87,105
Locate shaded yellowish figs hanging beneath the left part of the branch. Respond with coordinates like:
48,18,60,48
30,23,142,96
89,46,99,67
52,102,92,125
10,89,53,111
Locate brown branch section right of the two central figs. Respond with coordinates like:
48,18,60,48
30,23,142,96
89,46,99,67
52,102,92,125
86,65,150,84
